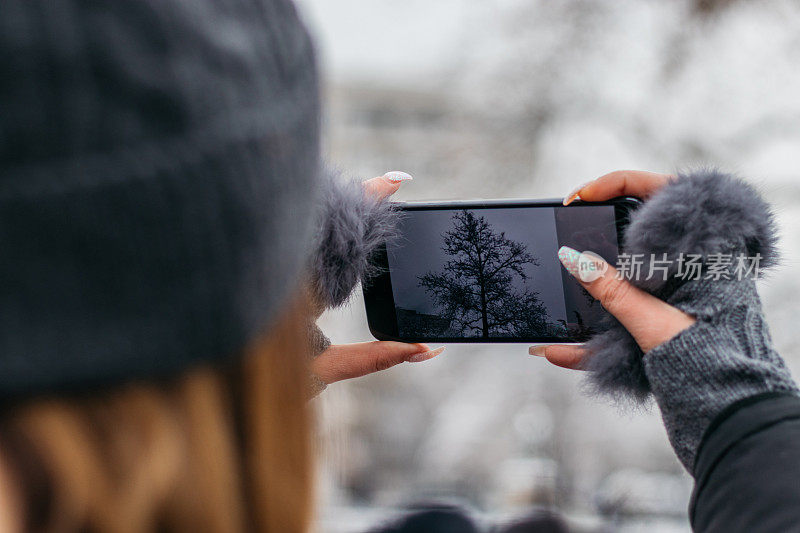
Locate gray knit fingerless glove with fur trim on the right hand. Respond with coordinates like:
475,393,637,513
586,170,798,473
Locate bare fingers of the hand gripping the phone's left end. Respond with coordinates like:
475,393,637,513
311,172,444,385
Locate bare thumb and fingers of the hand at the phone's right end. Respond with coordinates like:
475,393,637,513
529,170,695,369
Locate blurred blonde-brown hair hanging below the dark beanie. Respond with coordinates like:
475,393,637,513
0,300,313,533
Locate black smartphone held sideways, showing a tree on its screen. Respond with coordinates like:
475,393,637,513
363,197,640,343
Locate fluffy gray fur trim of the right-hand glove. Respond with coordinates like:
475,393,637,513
585,169,778,402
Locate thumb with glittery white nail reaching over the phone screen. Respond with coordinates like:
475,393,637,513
558,246,695,352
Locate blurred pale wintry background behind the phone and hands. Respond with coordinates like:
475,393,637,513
298,0,800,533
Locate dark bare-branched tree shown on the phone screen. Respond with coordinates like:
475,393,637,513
418,210,552,338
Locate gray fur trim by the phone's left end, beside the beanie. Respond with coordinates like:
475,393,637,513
311,166,399,308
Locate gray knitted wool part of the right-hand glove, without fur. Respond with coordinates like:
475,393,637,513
644,274,800,473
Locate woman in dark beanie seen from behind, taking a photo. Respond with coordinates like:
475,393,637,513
0,0,800,532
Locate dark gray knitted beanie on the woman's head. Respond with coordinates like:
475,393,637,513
0,0,320,398
